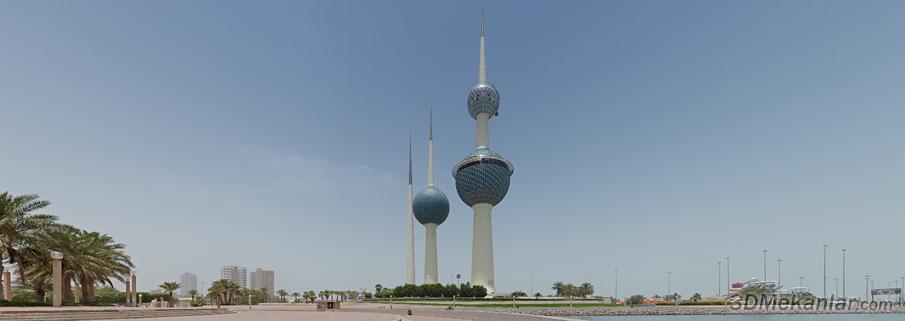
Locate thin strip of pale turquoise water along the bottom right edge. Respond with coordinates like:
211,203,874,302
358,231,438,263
572,314,905,321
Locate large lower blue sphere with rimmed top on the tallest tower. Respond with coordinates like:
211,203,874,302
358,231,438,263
453,147,514,206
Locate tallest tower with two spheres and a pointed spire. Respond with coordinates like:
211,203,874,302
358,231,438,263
453,6,513,294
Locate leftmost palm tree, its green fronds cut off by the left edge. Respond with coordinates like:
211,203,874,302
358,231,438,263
0,192,58,279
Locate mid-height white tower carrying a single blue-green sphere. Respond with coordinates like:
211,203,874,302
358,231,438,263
412,112,449,284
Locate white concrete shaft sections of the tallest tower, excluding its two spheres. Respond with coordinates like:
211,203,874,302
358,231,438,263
471,6,496,295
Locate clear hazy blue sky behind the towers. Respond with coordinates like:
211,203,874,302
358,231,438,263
0,0,905,296
